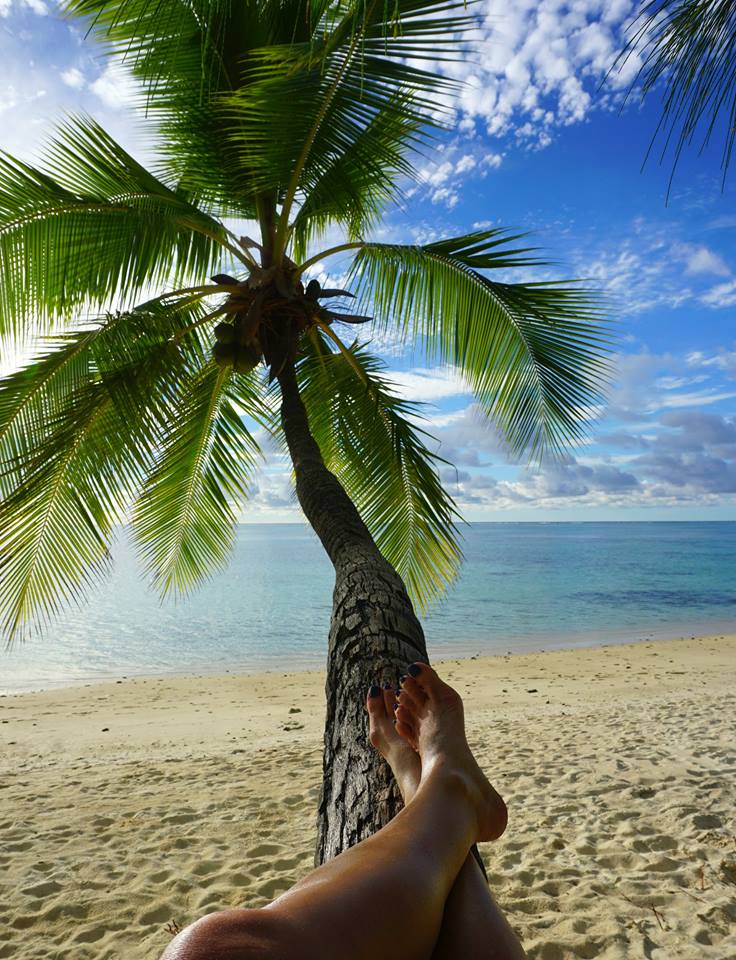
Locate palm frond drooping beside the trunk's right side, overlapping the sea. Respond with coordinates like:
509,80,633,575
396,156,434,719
297,333,462,607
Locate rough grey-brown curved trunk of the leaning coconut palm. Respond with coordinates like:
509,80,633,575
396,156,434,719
278,366,427,864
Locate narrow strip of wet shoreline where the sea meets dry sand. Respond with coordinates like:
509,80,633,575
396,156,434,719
5,619,736,698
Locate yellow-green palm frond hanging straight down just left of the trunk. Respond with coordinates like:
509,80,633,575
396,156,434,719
133,362,265,594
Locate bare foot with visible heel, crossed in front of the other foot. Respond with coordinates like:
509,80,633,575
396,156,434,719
396,663,508,840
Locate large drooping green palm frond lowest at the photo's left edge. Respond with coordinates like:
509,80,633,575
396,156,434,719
0,298,210,641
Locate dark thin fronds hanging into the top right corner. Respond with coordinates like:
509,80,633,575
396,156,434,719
614,0,736,185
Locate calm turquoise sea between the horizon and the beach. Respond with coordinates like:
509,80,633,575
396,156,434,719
0,522,736,692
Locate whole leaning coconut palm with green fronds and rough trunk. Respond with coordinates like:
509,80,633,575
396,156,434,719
0,0,608,860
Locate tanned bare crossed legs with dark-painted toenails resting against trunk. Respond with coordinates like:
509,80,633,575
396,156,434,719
162,664,524,960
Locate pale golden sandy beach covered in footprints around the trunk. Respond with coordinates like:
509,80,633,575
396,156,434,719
0,636,736,960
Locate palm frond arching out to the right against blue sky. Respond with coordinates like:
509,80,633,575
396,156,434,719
352,230,612,456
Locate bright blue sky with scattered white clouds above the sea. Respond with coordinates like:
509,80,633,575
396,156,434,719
0,0,736,521
